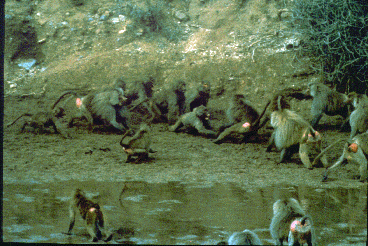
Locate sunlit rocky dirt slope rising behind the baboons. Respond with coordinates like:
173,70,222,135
5,0,311,108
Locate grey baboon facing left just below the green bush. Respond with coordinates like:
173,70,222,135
308,81,349,127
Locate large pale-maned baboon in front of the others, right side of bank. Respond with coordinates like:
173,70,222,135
266,96,327,169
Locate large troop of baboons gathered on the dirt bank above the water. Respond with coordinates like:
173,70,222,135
8,77,368,181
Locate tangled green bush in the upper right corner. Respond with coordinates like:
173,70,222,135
293,0,368,93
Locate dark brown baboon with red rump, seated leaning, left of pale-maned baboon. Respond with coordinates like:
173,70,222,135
213,95,270,143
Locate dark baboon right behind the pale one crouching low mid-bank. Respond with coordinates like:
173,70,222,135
184,81,211,113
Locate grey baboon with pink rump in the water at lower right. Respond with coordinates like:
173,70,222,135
270,198,315,246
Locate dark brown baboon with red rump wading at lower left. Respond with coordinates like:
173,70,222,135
67,189,112,242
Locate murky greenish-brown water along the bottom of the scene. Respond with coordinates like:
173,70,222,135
3,181,367,245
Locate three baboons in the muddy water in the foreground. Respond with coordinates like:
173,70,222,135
66,186,316,246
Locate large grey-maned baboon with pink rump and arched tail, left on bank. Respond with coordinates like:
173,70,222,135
54,79,129,131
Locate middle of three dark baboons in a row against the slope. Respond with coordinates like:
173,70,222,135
151,80,185,124
